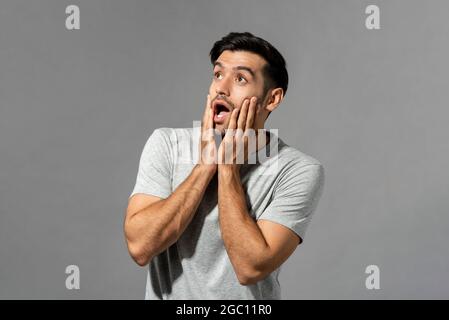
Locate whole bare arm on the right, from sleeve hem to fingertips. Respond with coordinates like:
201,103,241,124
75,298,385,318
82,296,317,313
218,99,301,285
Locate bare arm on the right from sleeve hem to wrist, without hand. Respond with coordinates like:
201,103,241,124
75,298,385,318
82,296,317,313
218,166,301,285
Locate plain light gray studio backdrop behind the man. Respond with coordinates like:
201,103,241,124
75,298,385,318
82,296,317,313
0,0,449,299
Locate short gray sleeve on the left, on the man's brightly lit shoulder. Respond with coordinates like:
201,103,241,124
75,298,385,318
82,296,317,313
129,128,172,199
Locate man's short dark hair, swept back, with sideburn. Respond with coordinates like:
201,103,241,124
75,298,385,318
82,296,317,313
209,32,288,95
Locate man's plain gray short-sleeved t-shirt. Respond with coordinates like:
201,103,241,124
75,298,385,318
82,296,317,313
130,127,324,300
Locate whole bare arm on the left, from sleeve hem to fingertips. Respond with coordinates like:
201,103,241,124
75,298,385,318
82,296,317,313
124,96,217,266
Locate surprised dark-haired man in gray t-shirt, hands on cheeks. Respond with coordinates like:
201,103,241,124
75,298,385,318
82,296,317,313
124,32,324,299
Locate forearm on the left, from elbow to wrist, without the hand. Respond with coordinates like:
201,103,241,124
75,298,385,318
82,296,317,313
125,165,213,265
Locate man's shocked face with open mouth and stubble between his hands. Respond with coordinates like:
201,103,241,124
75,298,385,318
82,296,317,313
209,50,269,135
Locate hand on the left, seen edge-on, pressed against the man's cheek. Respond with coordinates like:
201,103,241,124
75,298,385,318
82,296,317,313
198,94,217,174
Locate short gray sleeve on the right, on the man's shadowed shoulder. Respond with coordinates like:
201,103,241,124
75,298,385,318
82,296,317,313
258,164,324,241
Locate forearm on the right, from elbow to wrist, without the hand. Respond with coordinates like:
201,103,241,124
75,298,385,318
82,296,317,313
218,166,269,282
